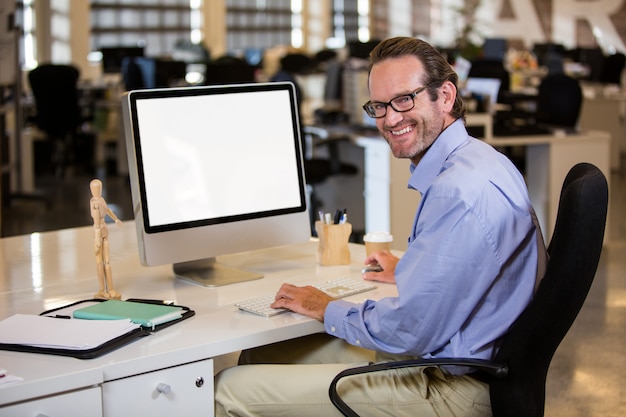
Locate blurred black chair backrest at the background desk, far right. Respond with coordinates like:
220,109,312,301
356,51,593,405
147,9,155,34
536,74,583,127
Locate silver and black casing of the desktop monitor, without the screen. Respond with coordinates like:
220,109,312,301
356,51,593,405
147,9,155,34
121,82,311,276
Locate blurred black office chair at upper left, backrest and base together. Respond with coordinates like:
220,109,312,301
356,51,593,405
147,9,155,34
28,64,82,177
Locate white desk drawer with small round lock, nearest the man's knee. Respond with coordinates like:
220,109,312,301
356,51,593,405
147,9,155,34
102,359,214,417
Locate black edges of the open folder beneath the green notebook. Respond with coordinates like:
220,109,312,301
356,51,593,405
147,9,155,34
0,298,196,359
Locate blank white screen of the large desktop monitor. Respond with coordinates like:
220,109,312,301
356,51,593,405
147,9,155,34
137,85,302,226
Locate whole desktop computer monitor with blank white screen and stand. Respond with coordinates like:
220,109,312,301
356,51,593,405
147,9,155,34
122,83,310,286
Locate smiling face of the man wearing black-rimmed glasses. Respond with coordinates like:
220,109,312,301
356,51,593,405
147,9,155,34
369,56,446,164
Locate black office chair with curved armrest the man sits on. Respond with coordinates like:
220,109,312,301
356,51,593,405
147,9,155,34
329,163,608,417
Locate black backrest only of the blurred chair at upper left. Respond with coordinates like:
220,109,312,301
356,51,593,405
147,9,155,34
28,64,81,136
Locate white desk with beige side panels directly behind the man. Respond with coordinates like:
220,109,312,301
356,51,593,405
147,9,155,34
354,131,611,245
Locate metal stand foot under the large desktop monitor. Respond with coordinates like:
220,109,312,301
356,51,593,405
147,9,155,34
173,258,263,287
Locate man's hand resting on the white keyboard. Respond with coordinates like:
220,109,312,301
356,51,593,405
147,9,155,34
271,284,334,322
